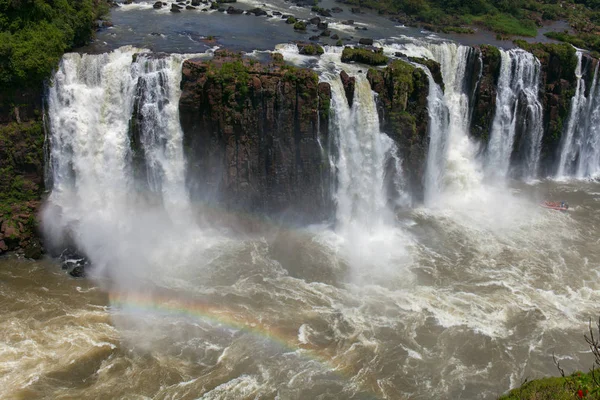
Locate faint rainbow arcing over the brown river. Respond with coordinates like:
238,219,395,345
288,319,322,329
109,292,381,399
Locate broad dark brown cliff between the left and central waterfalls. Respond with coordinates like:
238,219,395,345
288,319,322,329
179,52,331,221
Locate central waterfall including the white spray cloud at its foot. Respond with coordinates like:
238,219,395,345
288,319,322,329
325,69,406,282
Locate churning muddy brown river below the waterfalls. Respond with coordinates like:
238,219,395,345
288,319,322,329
0,181,600,399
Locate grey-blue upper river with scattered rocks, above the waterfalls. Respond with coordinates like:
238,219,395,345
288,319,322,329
81,0,569,53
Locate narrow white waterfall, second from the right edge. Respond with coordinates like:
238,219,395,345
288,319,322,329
485,49,543,178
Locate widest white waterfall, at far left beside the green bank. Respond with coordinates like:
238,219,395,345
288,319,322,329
44,47,193,253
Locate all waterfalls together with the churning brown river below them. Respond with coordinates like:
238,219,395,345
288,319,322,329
0,36,600,399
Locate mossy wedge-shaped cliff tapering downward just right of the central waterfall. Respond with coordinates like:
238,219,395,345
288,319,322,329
367,60,429,201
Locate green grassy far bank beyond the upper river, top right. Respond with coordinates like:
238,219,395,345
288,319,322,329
330,0,600,43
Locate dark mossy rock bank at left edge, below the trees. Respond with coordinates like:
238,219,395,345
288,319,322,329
0,90,44,258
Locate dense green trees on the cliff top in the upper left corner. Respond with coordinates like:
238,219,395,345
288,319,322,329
0,0,108,88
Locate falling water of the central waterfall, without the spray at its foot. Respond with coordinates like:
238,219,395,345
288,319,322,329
330,74,395,230
